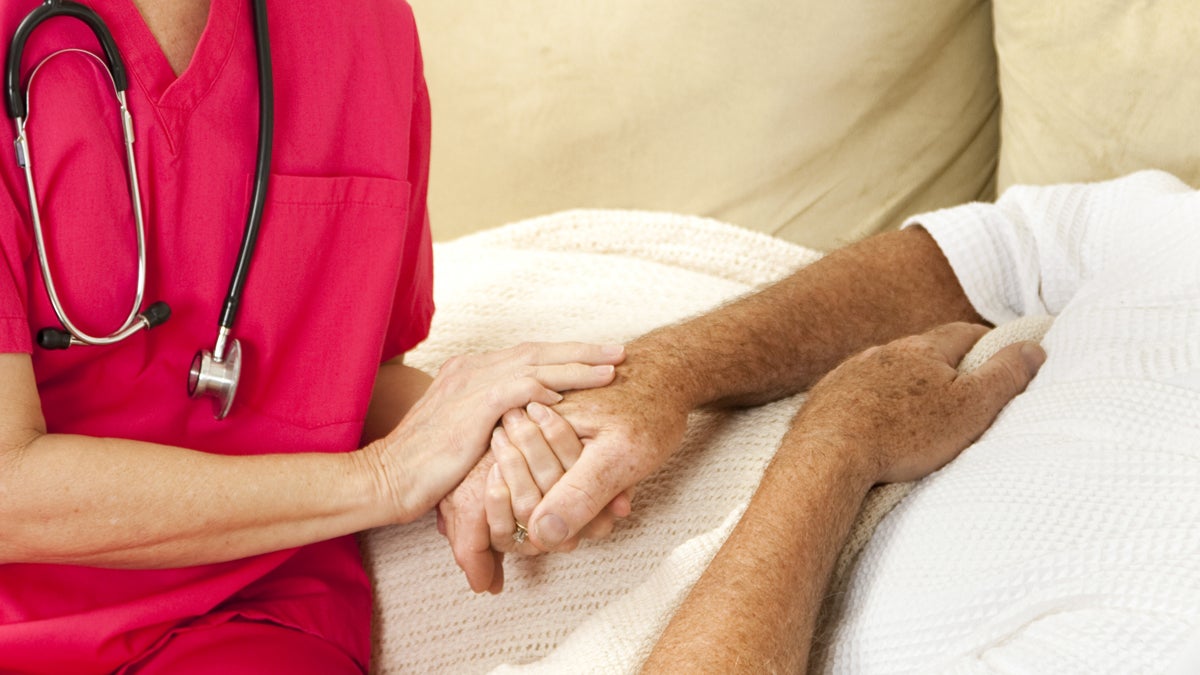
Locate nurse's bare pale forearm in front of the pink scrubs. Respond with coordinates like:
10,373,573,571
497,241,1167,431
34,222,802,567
0,427,393,568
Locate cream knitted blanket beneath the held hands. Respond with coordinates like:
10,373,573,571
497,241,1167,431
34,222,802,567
364,211,1045,673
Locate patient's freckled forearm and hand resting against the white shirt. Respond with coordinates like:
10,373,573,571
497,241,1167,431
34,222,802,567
643,323,1044,673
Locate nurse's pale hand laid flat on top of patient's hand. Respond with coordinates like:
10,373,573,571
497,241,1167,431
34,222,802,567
360,342,625,522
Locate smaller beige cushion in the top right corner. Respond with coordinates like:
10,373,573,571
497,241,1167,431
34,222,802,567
995,0,1200,189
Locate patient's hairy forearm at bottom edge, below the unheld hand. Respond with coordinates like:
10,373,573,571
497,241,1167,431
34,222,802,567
643,430,872,673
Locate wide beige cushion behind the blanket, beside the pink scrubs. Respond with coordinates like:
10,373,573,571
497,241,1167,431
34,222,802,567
412,0,998,249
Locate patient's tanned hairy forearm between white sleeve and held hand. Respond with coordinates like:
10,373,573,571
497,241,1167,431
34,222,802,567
619,228,980,410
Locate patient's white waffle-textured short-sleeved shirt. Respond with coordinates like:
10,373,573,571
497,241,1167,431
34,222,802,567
828,172,1200,674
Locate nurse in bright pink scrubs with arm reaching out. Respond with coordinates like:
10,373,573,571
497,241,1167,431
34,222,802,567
0,0,623,674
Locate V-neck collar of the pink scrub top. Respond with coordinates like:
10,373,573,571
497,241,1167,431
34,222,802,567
104,0,246,117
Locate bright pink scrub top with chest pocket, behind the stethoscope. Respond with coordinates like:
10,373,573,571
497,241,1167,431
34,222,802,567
0,0,433,673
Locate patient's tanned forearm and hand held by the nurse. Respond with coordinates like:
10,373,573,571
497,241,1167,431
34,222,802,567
440,228,980,590
